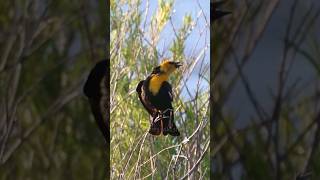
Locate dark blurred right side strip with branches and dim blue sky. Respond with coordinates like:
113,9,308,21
211,0,320,179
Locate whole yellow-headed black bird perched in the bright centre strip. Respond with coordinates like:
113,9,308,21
136,58,182,136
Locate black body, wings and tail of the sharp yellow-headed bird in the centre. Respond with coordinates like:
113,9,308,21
136,61,180,136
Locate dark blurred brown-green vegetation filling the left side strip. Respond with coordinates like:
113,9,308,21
0,0,107,180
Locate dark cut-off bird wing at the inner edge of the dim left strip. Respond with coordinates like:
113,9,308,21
83,59,110,142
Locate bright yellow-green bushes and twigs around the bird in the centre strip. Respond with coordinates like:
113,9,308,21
110,0,209,179
